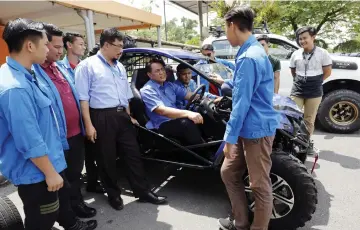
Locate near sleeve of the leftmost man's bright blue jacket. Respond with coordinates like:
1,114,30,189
0,89,50,159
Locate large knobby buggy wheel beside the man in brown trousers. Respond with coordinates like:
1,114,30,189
245,152,317,230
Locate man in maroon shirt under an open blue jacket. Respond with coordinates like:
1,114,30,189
34,24,96,218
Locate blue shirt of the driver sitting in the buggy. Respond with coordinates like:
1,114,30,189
140,80,187,129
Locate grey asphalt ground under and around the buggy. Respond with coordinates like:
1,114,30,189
0,128,360,230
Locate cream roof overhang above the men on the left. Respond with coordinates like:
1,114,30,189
0,0,161,34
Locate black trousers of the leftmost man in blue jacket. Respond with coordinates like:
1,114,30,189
18,173,76,230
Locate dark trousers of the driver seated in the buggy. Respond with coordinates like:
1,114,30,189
159,118,204,145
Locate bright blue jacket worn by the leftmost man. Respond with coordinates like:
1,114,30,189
0,57,66,185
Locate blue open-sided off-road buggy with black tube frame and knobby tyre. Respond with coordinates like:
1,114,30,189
120,48,318,229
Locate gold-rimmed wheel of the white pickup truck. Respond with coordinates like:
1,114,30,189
318,89,360,133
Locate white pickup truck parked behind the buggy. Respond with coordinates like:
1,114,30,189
203,33,360,133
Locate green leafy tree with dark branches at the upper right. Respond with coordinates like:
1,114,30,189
208,0,360,47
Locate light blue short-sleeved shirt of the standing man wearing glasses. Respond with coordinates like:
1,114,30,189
75,51,133,109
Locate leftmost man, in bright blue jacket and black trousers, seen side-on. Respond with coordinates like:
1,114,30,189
0,19,97,230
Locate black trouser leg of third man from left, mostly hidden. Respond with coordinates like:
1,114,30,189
85,138,99,186
